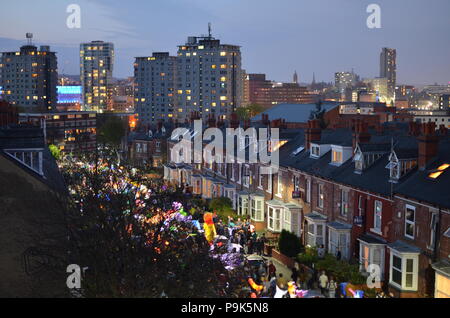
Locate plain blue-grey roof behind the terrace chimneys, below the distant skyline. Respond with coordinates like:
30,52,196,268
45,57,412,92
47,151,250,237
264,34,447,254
252,102,339,123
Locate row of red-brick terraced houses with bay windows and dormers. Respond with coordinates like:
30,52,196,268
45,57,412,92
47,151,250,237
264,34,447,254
164,112,450,297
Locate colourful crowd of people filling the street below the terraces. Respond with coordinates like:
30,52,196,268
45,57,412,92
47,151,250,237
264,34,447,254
59,154,386,298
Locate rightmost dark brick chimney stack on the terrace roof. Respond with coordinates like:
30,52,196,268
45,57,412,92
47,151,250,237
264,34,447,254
418,122,439,170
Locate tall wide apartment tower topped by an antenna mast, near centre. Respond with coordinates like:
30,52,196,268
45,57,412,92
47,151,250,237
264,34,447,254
175,28,243,121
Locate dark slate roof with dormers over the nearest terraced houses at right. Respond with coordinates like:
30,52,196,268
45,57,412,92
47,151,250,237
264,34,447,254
280,121,450,208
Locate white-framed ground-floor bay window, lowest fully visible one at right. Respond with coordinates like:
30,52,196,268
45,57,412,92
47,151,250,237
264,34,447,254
389,249,419,291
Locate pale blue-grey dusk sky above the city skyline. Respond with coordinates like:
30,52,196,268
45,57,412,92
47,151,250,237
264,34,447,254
0,0,450,85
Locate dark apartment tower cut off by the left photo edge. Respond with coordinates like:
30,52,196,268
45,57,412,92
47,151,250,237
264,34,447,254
0,33,58,111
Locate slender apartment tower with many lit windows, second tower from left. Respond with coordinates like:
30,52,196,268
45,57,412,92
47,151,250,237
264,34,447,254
80,41,114,113
